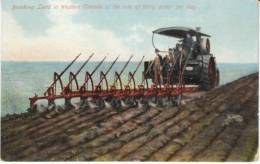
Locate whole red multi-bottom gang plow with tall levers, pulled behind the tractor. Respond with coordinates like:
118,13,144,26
29,54,198,110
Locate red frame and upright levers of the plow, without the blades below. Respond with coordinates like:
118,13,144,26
29,53,198,107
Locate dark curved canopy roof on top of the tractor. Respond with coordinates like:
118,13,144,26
153,27,210,38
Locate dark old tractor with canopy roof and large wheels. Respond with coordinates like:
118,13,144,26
143,27,219,91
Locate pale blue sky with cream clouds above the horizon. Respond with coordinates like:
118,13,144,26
1,0,259,63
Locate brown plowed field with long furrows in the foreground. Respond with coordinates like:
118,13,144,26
1,74,258,161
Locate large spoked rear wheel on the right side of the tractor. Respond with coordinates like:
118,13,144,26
201,57,219,91
